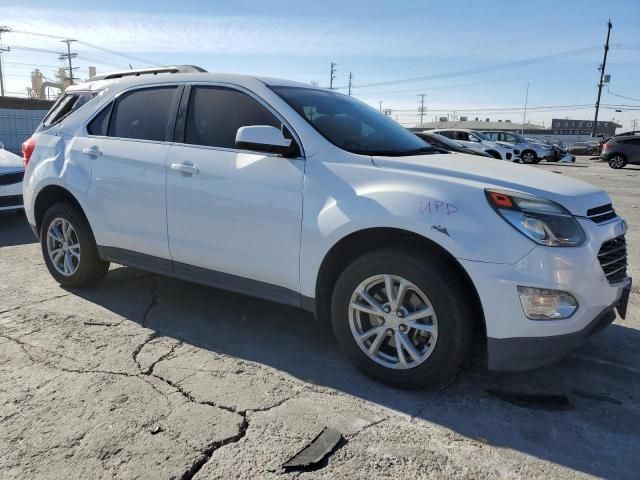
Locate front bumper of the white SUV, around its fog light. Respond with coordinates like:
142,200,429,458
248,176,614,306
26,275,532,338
461,219,631,371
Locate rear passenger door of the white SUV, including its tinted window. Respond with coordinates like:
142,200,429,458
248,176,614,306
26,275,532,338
72,85,182,260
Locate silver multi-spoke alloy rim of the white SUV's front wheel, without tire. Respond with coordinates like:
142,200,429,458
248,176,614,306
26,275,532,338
349,274,438,370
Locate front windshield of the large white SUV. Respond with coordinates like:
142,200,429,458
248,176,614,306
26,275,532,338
272,87,437,156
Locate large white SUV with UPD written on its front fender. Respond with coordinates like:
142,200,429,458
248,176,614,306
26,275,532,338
24,67,631,388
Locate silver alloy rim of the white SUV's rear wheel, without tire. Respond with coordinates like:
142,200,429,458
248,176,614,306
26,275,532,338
47,217,80,277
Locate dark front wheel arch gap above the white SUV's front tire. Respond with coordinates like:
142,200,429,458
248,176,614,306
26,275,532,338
315,227,486,337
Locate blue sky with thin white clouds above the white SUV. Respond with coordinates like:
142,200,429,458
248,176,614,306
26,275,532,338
0,0,640,129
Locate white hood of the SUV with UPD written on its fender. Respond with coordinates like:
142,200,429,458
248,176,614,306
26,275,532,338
372,154,611,217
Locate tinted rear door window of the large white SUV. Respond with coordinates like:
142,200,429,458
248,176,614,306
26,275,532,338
109,87,177,141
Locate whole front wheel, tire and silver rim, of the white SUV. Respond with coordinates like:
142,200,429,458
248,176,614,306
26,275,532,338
331,249,473,389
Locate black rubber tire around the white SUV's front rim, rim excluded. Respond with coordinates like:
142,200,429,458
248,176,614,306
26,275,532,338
331,249,474,389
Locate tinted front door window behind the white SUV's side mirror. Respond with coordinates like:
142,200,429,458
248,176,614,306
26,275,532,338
184,87,282,149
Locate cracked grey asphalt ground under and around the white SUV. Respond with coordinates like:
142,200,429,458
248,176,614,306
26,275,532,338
0,158,640,479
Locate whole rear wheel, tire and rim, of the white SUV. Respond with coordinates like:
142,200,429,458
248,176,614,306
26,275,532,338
40,203,109,288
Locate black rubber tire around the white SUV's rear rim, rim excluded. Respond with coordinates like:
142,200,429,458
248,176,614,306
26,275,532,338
40,202,109,288
